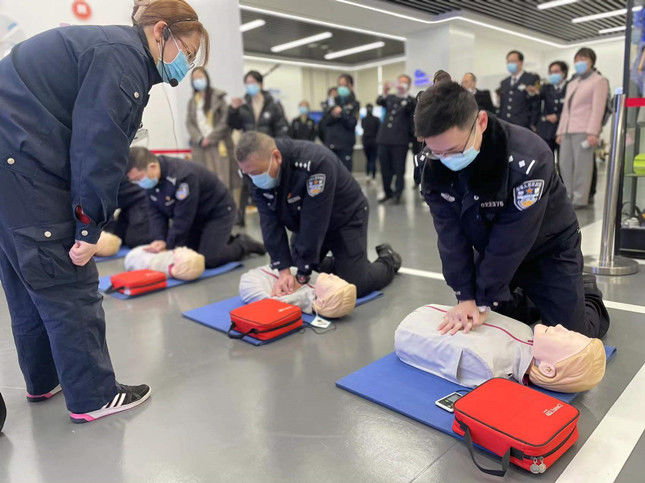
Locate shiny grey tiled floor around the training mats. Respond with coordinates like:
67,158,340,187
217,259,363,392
0,170,645,483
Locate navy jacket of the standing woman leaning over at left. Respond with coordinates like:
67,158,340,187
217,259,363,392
0,26,161,243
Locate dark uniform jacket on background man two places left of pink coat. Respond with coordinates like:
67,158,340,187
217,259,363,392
499,72,540,127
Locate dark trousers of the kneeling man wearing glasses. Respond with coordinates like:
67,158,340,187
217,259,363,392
494,231,609,337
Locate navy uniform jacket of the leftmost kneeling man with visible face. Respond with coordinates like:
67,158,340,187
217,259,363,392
146,156,235,250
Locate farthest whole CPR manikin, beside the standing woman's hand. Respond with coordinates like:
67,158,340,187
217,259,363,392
124,245,206,281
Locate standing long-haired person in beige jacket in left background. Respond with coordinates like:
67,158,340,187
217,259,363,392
186,68,241,191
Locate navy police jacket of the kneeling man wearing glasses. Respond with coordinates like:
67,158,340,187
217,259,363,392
420,115,579,308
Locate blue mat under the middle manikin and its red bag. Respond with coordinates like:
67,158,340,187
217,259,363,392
182,292,383,346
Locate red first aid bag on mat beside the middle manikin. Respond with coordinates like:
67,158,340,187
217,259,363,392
227,299,302,340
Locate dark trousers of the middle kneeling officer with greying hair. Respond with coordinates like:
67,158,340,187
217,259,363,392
318,203,396,298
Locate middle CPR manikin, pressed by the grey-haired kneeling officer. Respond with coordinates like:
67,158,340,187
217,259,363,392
240,265,356,319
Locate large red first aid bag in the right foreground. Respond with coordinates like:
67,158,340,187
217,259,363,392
452,378,580,476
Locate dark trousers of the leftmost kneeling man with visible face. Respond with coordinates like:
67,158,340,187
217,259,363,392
188,206,245,268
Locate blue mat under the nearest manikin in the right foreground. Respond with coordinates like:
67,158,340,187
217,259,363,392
336,346,616,438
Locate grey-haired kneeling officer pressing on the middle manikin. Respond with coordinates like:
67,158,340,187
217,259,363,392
235,132,401,297
